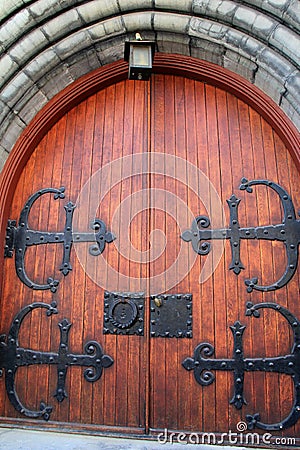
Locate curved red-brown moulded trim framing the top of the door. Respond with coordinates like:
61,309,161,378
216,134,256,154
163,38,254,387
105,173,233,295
0,53,300,292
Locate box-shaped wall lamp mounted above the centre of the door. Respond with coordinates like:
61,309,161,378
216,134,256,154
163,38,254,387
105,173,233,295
124,33,155,81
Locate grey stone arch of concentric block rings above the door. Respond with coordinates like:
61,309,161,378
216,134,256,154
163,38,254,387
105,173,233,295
0,0,300,169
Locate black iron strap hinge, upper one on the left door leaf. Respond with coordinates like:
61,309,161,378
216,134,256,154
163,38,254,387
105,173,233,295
5,187,115,292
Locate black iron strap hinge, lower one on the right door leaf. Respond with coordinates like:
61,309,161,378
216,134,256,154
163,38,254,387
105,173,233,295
182,302,300,431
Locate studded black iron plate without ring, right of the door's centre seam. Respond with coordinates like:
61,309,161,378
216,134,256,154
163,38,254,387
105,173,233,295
150,294,193,338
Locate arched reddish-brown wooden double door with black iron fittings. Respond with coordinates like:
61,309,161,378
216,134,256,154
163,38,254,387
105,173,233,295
0,59,300,444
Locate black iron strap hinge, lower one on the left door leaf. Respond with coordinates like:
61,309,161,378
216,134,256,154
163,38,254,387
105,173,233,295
0,302,113,420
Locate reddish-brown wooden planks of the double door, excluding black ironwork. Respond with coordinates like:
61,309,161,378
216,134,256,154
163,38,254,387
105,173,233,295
0,74,300,436
